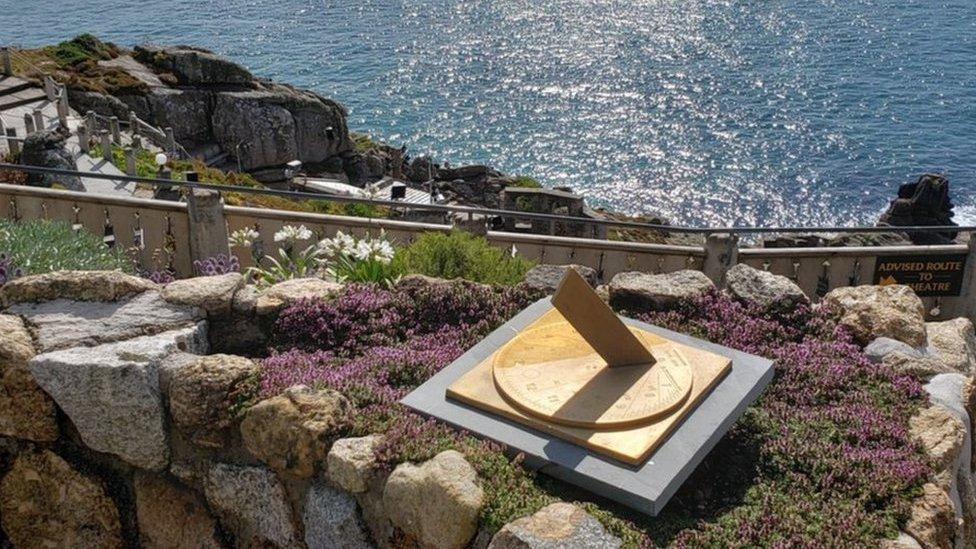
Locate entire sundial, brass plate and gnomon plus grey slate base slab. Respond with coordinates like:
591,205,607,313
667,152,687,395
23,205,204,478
403,269,772,514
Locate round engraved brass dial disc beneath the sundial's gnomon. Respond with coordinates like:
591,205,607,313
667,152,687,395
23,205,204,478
492,322,693,429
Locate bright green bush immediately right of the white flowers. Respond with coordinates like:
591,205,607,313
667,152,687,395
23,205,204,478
393,231,535,286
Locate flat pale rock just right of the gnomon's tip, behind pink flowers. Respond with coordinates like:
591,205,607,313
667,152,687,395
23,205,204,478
610,270,715,311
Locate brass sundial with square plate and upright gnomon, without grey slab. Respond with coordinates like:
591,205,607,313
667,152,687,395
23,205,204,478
447,269,731,465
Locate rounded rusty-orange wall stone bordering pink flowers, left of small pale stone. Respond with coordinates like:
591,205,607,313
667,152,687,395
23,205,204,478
241,385,351,478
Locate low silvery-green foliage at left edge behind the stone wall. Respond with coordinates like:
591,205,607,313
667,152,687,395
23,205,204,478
0,220,135,274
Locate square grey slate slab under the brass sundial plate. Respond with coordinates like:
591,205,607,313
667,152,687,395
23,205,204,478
402,298,773,515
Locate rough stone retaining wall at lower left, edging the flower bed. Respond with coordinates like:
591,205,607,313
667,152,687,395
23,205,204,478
0,272,620,548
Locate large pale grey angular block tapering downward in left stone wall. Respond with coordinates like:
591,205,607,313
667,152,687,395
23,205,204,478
30,327,206,471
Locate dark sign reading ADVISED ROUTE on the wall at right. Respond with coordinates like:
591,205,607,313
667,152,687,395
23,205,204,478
874,254,966,297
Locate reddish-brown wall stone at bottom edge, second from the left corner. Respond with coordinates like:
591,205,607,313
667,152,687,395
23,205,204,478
132,473,223,549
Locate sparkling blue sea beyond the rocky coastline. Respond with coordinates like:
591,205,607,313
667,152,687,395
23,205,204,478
0,0,976,225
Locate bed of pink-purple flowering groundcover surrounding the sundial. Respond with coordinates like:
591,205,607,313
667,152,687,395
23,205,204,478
261,283,930,547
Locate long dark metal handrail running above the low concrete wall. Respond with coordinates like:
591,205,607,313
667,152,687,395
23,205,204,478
0,163,976,239
